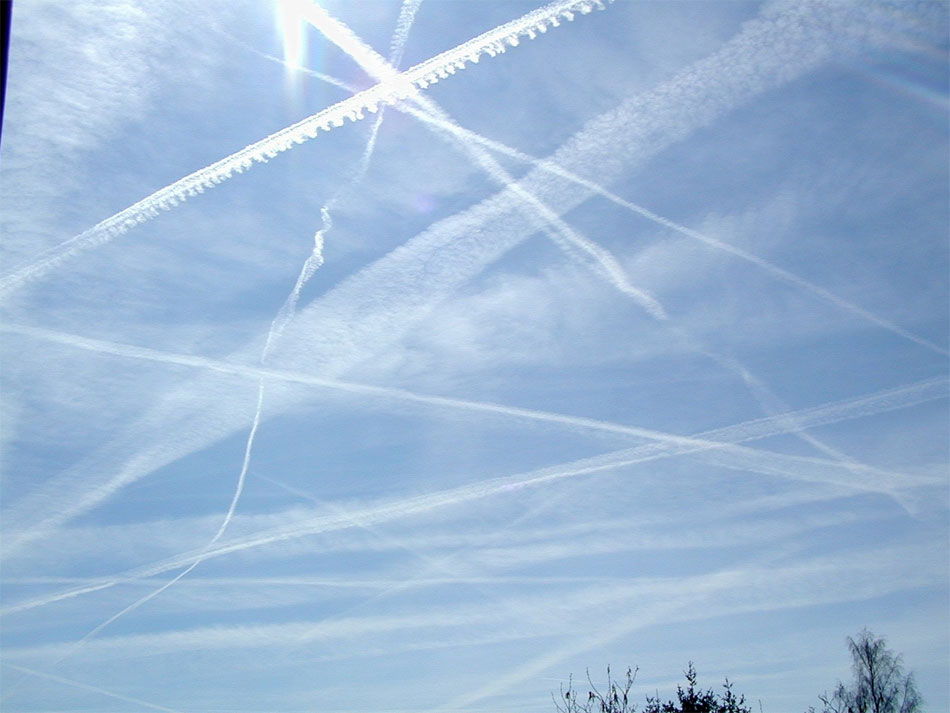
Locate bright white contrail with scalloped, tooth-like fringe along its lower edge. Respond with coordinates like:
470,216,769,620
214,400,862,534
0,0,612,295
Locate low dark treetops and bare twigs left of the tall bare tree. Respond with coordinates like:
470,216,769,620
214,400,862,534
554,662,752,713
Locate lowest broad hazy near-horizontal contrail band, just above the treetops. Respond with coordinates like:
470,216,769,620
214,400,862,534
7,547,940,660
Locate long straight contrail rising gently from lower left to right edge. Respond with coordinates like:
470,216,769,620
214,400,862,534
2,377,948,614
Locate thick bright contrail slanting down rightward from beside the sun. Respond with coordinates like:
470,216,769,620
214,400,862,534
299,2,666,320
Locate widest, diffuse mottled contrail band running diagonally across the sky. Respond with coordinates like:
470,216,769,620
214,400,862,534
0,3,932,560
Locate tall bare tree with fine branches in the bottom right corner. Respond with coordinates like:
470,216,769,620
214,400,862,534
808,629,923,713
